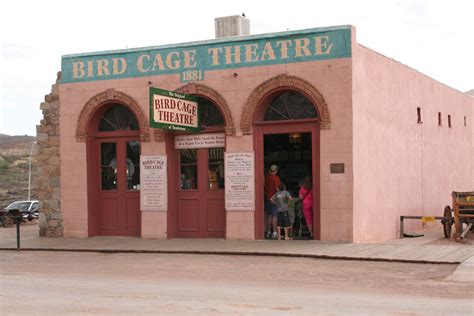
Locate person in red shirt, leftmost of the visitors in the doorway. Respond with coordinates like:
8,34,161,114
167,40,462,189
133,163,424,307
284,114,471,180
265,165,281,239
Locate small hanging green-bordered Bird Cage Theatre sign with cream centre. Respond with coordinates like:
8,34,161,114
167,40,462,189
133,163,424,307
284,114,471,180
150,88,201,133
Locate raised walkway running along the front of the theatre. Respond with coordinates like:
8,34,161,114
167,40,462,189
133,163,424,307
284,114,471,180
0,226,474,264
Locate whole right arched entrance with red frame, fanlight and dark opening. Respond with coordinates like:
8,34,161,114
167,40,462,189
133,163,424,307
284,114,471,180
253,86,325,240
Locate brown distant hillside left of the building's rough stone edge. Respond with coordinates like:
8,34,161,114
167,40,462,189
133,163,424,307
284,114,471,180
0,134,36,208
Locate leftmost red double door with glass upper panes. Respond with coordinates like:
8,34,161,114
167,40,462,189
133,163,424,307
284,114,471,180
96,138,141,236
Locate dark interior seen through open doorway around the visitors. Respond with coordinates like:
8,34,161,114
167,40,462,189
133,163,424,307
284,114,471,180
263,132,314,239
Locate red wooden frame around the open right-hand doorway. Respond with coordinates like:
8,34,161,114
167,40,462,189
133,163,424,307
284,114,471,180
253,119,321,240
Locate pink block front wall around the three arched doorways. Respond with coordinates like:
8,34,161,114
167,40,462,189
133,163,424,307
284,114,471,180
60,58,352,241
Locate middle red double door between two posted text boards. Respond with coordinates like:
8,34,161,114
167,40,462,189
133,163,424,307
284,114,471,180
175,148,225,238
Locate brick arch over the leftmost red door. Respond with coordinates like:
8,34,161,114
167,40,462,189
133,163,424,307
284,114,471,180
76,89,150,142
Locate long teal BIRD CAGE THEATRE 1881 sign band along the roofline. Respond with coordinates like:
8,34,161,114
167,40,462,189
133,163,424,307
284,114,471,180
61,26,351,83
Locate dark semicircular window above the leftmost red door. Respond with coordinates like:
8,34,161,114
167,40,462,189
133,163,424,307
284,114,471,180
99,104,138,132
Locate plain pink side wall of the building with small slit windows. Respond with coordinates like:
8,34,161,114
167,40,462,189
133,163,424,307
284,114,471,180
352,41,474,242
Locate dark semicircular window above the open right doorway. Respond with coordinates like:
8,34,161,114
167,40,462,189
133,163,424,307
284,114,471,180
263,91,318,121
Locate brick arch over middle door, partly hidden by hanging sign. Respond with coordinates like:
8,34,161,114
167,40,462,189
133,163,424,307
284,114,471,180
175,82,235,136
